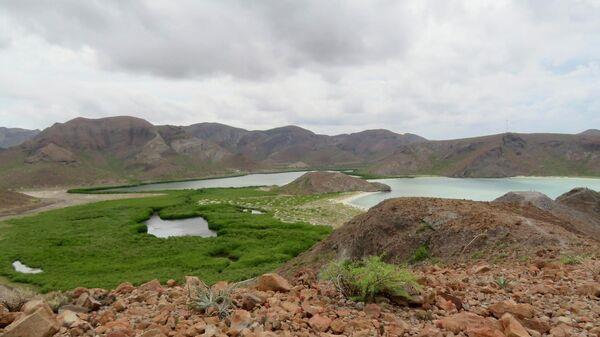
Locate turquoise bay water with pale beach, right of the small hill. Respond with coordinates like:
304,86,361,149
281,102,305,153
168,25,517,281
351,177,600,208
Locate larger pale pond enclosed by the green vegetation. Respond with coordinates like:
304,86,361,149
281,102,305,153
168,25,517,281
145,214,217,238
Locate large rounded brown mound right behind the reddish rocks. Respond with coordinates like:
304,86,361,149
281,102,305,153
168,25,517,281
284,198,598,270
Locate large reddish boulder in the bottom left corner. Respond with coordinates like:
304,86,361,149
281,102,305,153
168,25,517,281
2,307,60,337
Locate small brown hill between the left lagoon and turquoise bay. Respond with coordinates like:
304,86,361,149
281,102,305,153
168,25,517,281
280,172,391,194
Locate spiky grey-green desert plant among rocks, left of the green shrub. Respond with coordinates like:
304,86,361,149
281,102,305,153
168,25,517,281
188,283,235,319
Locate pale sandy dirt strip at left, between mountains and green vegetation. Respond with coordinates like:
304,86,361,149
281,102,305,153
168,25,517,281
0,190,161,221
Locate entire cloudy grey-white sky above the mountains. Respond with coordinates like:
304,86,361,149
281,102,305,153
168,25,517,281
0,0,600,139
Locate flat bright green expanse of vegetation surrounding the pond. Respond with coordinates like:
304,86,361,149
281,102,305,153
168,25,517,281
0,188,338,292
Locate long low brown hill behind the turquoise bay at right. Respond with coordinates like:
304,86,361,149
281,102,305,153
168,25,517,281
369,133,600,177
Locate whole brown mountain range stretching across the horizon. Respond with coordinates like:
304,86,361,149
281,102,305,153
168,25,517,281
0,116,600,188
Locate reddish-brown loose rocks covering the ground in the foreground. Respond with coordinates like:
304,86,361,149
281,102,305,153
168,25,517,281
0,251,600,337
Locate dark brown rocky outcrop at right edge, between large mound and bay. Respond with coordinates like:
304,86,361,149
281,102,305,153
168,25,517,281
494,188,600,241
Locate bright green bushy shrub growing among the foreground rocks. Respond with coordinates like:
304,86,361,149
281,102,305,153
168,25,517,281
320,256,419,302
